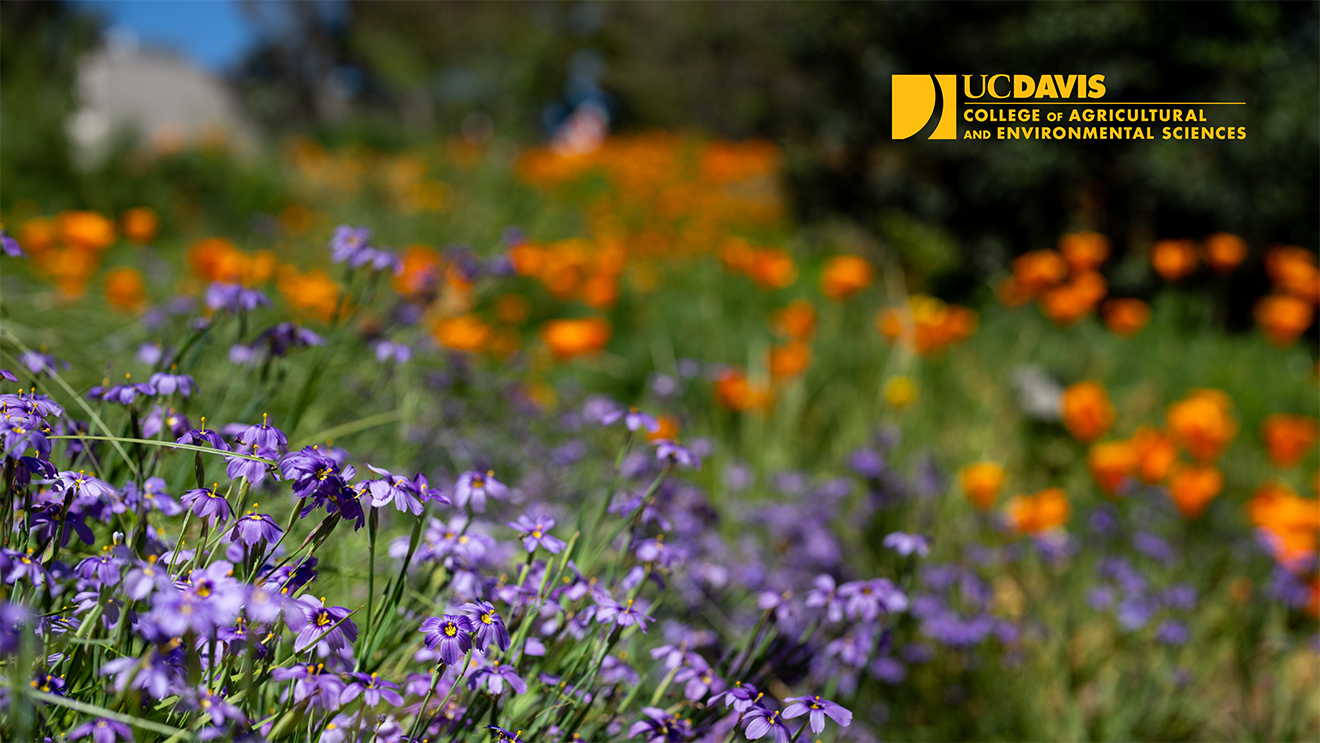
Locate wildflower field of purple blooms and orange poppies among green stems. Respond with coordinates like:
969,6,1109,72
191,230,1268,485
0,133,1320,743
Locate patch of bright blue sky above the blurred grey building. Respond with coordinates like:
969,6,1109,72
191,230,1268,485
78,0,256,71
